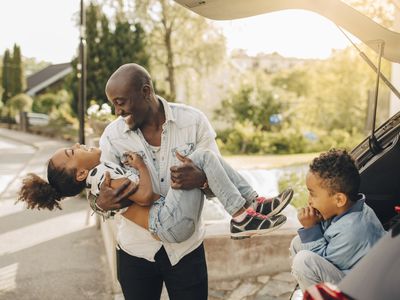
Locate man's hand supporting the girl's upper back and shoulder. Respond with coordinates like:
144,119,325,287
96,172,138,211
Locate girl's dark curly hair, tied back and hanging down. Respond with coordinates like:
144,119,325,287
17,160,86,210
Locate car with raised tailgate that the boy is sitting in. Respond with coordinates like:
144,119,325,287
175,0,400,299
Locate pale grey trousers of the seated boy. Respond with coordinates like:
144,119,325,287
290,236,345,291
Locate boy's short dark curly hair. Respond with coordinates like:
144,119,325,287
310,149,360,201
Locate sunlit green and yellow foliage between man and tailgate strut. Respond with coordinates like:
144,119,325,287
215,48,389,154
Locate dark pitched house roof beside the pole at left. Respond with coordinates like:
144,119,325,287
26,63,72,96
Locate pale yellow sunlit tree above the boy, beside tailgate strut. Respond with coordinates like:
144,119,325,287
280,48,389,134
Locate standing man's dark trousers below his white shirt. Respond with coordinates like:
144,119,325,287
117,244,208,300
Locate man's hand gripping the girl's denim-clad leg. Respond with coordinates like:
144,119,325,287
170,152,207,190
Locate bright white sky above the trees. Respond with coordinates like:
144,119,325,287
0,0,349,63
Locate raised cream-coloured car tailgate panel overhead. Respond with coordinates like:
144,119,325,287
175,0,400,63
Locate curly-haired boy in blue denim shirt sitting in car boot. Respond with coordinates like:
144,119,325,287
290,149,385,291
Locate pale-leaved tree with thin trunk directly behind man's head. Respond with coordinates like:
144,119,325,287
132,0,225,101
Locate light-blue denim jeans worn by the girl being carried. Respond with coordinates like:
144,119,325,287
149,150,257,243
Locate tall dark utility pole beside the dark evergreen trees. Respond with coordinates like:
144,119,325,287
78,0,86,144
